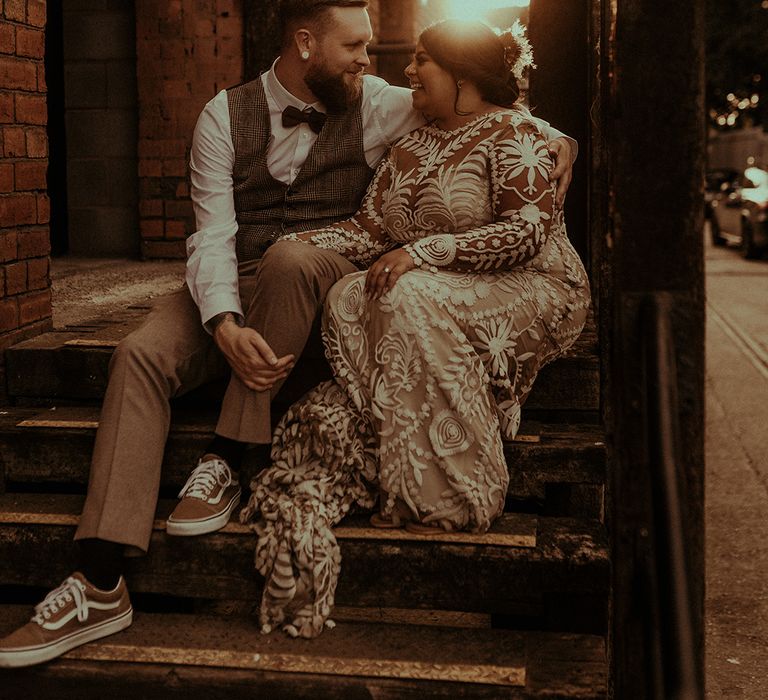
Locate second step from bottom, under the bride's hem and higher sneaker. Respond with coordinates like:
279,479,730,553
0,494,609,633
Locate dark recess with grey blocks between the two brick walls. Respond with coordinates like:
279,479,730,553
45,0,139,257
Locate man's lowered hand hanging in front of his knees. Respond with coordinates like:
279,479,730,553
213,320,294,391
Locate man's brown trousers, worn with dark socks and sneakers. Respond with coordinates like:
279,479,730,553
75,241,356,552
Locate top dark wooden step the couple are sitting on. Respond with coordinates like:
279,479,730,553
5,306,600,411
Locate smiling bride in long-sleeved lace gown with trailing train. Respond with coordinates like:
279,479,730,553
241,20,590,637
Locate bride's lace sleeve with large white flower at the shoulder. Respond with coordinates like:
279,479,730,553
403,122,559,272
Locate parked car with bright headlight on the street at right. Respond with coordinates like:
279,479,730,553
705,167,768,258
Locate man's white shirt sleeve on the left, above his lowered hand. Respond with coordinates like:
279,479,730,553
186,90,243,328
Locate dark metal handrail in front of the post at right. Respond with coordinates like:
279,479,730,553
641,292,704,700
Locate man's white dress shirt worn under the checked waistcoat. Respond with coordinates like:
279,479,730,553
186,59,576,324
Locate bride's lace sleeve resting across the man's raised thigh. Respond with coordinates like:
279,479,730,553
281,157,395,268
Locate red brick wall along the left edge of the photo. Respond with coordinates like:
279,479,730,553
0,0,51,349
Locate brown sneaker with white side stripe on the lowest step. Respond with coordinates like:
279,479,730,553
0,572,133,668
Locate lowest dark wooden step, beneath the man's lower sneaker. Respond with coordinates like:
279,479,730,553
0,606,607,700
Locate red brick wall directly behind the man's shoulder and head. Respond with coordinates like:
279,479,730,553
135,0,243,258
